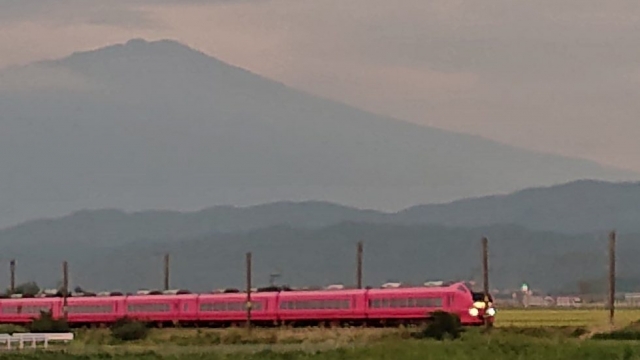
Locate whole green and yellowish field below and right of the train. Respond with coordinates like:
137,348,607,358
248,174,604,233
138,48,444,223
0,310,640,360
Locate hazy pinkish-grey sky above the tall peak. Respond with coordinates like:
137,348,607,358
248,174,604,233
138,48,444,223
0,0,640,171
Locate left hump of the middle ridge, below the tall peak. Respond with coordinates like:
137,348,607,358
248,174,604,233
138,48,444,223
0,201,388,252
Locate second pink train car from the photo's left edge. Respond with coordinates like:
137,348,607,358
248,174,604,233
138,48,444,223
63,296,126,325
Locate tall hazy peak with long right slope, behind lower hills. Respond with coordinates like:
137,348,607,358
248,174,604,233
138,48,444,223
0,39,637,227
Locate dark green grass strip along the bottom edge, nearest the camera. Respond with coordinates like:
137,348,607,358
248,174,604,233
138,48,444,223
3,333,640,360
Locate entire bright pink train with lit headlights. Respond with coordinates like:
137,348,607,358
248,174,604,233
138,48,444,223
0,283,495,326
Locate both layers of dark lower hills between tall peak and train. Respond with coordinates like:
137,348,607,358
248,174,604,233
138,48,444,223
0,181,640,291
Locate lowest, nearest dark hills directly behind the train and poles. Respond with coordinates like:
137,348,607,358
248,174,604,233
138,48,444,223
5,223,640,291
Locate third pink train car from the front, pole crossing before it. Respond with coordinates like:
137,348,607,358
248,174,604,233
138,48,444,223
198,292,278,325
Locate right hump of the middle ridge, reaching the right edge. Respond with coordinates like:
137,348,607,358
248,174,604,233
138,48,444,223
394,180,640,233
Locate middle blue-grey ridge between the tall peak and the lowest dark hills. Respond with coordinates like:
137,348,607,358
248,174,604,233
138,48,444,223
0,180,640,247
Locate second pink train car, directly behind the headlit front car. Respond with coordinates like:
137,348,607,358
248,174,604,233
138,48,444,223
278,290,366,324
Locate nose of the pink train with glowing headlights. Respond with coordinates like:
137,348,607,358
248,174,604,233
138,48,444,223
453,283,496,325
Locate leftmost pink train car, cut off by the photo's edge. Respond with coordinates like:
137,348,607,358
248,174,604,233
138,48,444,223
0,297,62,324
